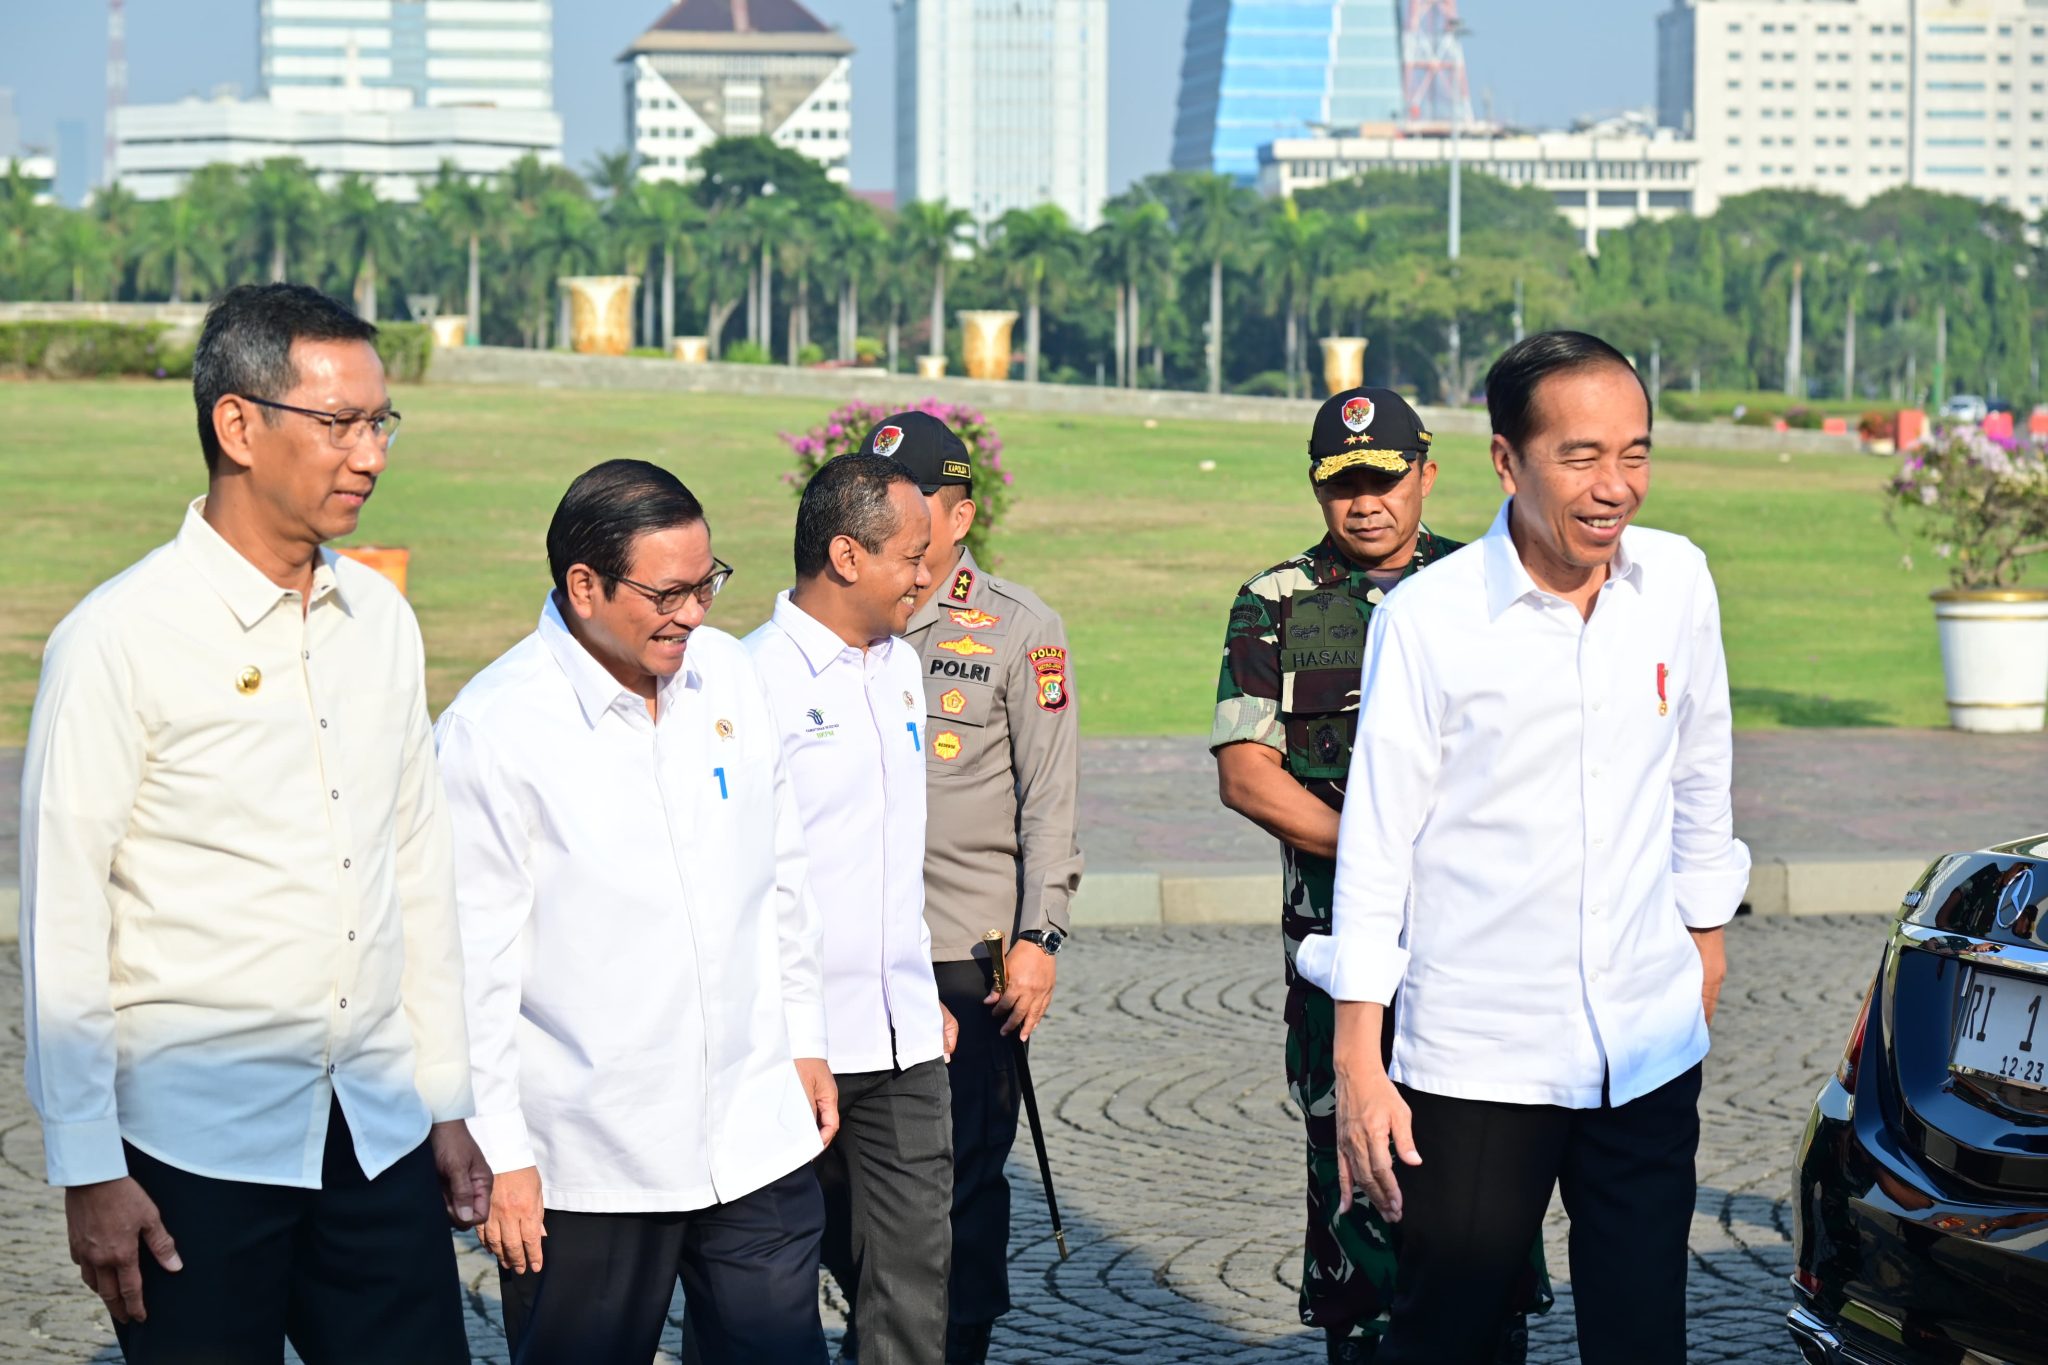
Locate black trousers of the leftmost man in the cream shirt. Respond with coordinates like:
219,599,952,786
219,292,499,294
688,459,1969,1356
115,1103,469,1365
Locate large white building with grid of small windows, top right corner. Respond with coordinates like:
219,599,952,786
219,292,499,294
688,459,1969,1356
1657,0,2048,217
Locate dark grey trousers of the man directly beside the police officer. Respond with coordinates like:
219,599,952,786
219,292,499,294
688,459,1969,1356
817,1058,952,1365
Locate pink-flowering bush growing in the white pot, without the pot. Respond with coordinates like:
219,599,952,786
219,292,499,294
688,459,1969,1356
1884,428,2048,587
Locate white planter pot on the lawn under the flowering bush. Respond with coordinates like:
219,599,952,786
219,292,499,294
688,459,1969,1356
1929,587,2048,733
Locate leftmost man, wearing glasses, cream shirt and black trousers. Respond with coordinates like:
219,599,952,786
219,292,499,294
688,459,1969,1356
20,284,489,1365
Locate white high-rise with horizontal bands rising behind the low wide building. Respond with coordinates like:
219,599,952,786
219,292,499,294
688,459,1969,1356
260,0,555,111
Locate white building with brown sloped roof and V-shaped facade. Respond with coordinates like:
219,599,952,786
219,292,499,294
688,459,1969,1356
621,0,854,184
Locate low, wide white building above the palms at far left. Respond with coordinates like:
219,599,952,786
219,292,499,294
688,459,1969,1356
115,100,561,203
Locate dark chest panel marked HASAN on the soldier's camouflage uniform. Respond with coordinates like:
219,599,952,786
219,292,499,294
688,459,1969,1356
1280,587,1368,780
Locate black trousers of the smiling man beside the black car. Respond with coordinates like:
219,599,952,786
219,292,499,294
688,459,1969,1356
1376,1066,1700,1365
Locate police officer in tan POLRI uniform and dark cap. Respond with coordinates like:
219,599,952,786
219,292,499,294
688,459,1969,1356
842,411,1081,1363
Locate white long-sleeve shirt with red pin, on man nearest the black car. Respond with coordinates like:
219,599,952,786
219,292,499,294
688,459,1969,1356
1294,503,1749,1109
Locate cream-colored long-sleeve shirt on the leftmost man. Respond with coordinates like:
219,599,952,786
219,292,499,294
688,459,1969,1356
20,499,471,1189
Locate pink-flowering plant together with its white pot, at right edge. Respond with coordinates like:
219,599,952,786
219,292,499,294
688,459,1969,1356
1886,428,2048,731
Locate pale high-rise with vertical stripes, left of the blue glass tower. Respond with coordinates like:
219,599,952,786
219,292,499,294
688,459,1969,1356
895,0,1110,229
